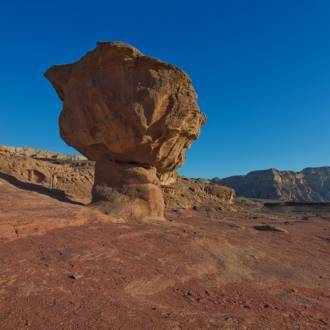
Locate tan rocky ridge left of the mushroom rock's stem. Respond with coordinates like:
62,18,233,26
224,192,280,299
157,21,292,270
0,146,94,203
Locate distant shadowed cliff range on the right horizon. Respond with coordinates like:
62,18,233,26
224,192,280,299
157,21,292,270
212,167,330,202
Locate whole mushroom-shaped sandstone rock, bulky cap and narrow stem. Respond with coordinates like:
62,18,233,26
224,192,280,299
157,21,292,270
45,42,205,219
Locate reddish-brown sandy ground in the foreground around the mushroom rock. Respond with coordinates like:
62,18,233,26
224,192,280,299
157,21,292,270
0,180,330,329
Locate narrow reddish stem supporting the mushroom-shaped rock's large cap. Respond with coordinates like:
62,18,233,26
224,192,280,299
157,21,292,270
92,160,165,220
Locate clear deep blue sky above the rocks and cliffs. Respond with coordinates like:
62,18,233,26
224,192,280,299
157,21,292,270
0,0,330,177
